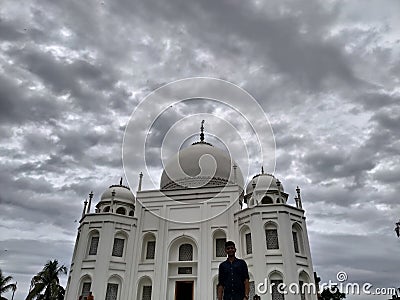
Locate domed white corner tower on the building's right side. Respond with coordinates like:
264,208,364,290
234,168,317,300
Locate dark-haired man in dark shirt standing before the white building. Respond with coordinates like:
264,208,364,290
218,241,250,300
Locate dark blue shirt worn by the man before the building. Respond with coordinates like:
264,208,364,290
218,257,249,300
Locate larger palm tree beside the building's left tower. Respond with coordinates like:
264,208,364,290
26,259,67,300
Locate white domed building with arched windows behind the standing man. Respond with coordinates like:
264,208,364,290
65,130,316,300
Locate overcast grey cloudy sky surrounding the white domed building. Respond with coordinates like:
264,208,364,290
0,0,400,300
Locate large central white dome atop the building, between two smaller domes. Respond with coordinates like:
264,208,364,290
160,142,243,190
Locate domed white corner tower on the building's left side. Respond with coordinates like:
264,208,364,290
65,179,137,300
